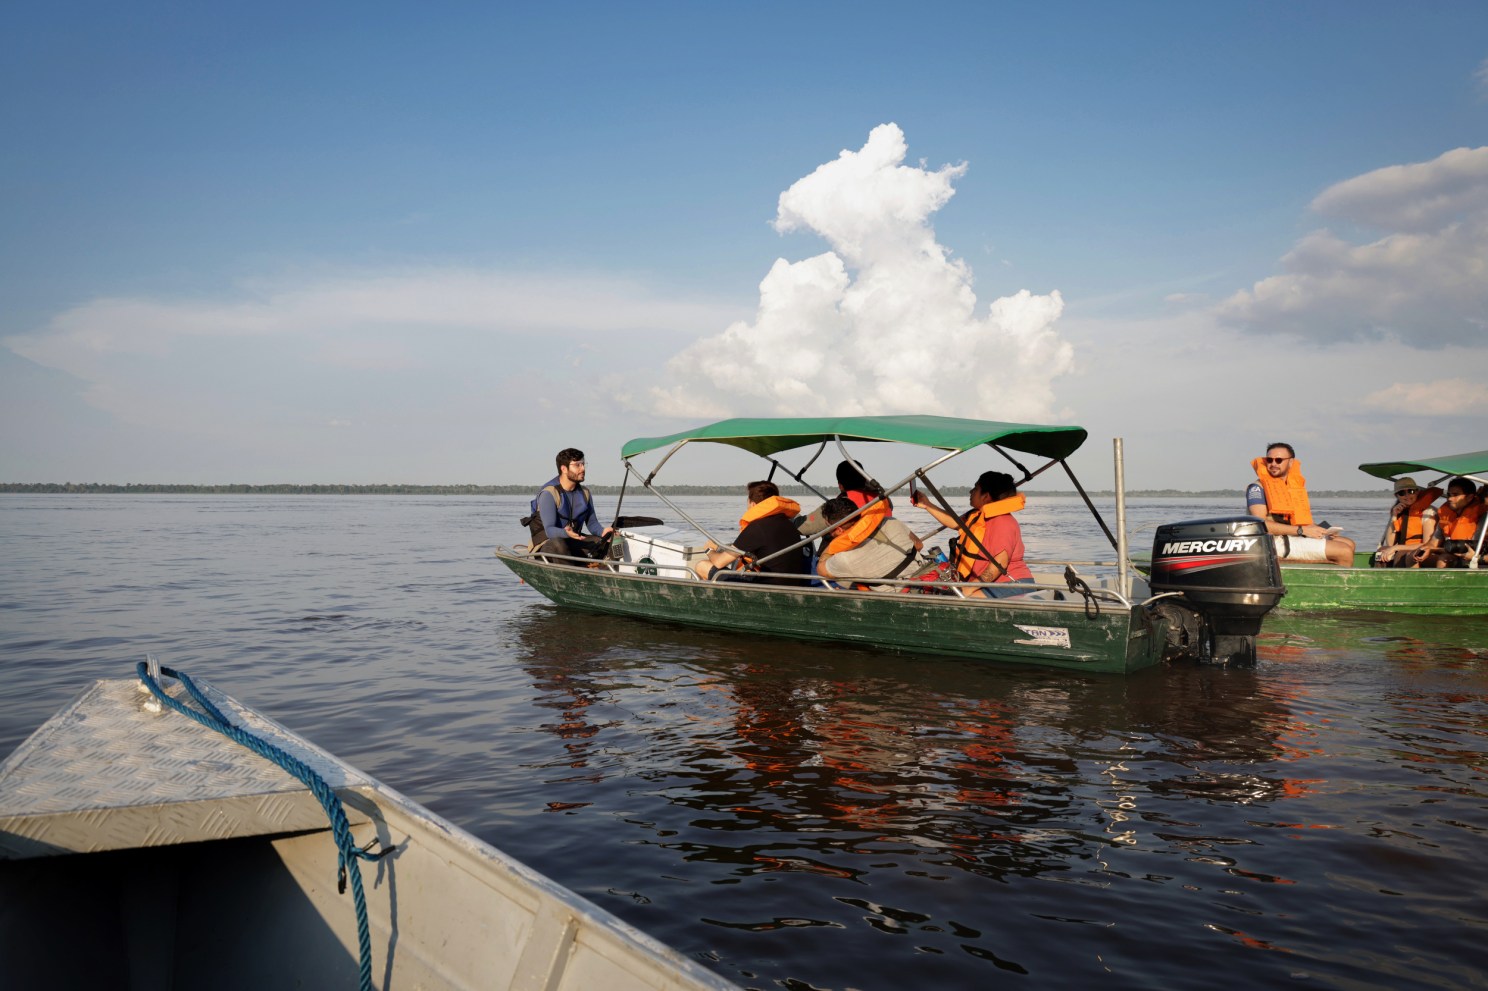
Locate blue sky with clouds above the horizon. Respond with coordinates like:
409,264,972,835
0,3,1488,488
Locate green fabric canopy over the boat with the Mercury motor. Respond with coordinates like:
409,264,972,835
620,417,1088,458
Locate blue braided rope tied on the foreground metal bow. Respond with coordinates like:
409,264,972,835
137,661,390,991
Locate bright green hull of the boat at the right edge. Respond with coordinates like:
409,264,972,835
1278,554,1488,616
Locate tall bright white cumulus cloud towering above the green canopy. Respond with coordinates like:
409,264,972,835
635,124,1074,421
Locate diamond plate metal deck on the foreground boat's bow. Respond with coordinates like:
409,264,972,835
0,679,373,860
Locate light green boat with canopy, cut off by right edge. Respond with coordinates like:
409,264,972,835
1281,451,1488,616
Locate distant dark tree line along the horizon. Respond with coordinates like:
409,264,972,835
0,482,1388,498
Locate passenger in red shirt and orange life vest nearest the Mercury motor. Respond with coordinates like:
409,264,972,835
911,472,1033,598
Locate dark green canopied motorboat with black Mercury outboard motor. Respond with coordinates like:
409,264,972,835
496,415,1280,673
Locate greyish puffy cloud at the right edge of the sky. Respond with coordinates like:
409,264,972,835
1216,147,1488,348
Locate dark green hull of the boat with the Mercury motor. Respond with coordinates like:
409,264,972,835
496,549,1164,674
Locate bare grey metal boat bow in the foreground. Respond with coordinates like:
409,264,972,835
0,680,737,991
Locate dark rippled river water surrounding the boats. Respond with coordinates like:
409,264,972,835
0,494,1488,991
